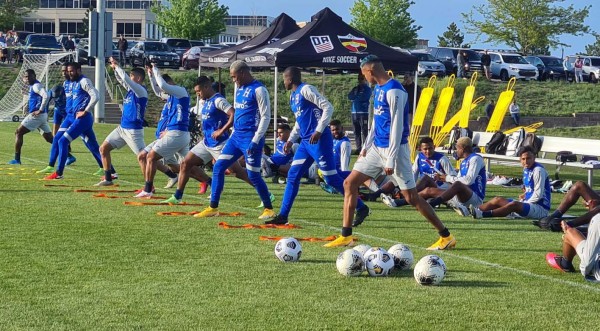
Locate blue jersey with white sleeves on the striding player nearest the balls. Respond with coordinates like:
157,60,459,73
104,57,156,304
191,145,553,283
373,79,410,148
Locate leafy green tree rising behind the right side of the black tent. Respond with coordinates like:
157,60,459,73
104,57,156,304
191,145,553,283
350,0,421,48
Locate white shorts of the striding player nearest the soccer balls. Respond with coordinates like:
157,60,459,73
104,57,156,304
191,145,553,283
352,144,416,190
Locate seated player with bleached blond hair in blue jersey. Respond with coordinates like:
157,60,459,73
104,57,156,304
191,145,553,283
421,137,486,216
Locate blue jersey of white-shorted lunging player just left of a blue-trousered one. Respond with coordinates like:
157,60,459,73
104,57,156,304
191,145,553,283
200,93,231,147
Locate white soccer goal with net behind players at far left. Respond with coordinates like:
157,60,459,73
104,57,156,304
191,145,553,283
0,52,72,122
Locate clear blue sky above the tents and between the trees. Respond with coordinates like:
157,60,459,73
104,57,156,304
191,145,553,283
219,0,600,57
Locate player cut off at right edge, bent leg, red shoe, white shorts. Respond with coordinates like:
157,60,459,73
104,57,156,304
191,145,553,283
546,215,600,282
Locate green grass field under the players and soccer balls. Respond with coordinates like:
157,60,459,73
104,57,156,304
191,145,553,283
0,123,600,330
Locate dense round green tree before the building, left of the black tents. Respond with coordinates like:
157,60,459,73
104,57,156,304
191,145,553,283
152,0,229,40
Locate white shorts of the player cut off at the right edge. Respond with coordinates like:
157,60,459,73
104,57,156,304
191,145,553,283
575,214,600,280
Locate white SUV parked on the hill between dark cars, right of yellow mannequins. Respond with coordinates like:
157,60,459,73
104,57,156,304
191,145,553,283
488,52,539,81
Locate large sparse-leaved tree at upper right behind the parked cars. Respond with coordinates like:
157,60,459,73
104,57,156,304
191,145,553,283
462,0,590,54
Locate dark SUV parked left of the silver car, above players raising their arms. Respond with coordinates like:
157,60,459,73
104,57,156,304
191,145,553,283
131,41,180,69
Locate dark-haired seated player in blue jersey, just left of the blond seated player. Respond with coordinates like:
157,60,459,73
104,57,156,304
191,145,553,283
381,137,456,207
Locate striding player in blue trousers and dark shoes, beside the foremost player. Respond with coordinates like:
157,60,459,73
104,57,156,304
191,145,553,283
265,67,370,225
